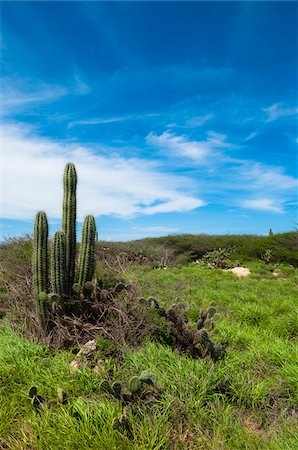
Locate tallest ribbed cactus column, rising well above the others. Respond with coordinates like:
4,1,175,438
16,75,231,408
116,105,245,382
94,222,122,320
62,163,77,294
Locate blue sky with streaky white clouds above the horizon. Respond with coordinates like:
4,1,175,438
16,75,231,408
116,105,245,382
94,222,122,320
0,1,298,240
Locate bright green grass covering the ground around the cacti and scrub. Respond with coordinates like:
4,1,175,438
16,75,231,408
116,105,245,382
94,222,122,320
0,262,298,450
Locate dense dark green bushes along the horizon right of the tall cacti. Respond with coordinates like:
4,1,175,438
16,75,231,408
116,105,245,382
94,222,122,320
98,231,298,267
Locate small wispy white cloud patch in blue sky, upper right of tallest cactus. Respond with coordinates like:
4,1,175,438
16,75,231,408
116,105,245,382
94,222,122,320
146,131,236,165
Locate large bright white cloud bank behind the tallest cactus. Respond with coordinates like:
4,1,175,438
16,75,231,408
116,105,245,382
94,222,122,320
0,125,204,220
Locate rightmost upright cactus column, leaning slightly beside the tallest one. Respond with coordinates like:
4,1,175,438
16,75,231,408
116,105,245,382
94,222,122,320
78,215,96,286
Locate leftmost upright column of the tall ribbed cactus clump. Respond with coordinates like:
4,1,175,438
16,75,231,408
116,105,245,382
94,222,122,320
32,211,48,297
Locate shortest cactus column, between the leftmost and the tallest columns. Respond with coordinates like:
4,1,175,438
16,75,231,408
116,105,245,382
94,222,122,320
51,231,66,296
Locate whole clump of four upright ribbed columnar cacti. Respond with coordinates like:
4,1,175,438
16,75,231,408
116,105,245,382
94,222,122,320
32,163,96,328
